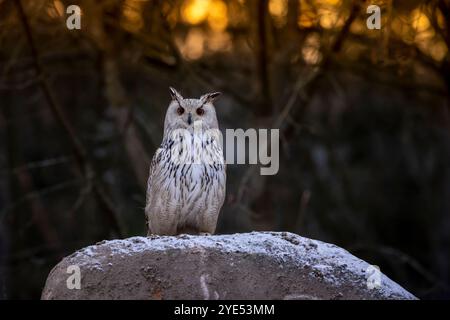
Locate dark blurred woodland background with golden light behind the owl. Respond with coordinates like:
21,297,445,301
0,0,450,299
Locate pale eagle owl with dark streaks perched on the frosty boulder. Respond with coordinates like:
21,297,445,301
145,88,226,235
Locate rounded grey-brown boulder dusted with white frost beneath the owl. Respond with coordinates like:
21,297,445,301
42,232,416,299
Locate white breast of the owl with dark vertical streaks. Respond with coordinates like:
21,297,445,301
152,130,226,220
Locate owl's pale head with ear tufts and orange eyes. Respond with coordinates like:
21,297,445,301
164,87,220,131
